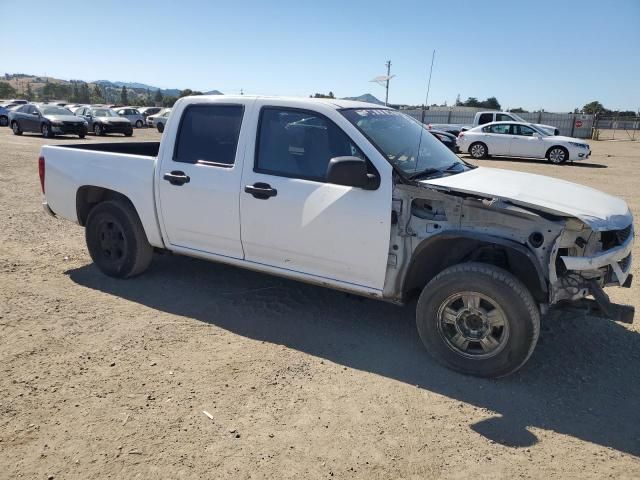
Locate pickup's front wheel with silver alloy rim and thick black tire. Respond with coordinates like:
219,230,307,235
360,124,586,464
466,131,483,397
416,263,540,377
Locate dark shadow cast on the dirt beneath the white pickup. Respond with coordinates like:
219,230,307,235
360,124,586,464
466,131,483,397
66,256,640,456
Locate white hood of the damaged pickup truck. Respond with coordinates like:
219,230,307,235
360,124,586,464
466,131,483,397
420,167,633,231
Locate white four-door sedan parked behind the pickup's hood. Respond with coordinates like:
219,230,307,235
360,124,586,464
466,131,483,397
458,122,591,163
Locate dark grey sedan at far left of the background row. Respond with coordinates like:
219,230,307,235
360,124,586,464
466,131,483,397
9,103,87,138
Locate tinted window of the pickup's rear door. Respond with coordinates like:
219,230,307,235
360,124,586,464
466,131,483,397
173,105,244,167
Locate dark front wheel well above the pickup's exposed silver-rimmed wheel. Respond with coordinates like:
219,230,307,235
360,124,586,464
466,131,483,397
402,235,547,302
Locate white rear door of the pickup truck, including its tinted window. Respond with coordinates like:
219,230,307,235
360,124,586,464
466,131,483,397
158,103,250,259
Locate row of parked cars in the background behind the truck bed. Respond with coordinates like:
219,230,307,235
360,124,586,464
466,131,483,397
0,100,171,138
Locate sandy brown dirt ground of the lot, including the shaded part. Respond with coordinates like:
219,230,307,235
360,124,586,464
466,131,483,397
0,128,640,479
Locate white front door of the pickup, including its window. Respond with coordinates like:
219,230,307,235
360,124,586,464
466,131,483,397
240,103,391,290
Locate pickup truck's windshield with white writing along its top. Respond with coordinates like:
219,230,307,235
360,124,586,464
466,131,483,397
340,108,468,178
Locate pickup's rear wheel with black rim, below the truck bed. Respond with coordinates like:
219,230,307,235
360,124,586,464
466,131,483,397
85,200,153,278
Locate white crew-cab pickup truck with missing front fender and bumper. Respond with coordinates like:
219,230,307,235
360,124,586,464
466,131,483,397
39,95,633,377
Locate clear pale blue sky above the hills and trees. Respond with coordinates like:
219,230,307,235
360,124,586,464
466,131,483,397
0,0,640,112
